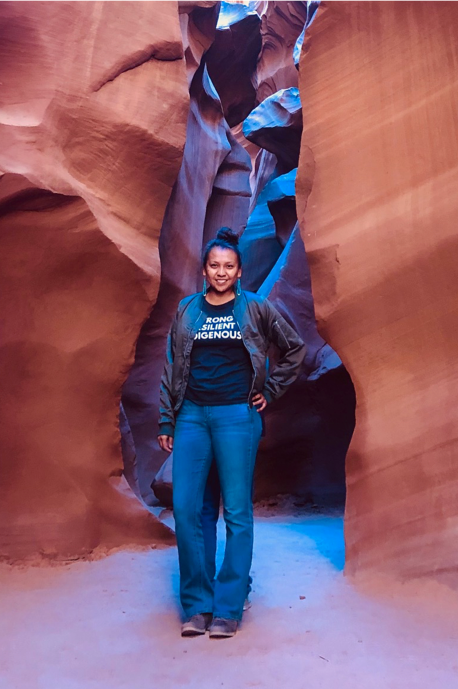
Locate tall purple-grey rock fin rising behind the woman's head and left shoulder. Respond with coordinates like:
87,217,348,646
123,67,251,503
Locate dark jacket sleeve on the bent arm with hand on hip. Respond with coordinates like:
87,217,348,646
262,299,306,402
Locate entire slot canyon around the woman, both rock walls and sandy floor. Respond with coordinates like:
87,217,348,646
0,0,458,689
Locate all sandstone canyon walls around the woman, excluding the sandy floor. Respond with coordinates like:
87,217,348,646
0,0,450,578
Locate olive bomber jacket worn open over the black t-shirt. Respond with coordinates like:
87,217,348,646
159,290,305,436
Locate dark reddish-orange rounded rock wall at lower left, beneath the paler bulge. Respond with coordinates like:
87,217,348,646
0,175,172,560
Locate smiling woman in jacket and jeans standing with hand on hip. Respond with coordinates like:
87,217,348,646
159,228,305,638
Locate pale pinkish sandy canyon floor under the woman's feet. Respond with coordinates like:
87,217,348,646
0,510,458,689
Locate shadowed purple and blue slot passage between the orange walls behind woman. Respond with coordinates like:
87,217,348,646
121,0,355,510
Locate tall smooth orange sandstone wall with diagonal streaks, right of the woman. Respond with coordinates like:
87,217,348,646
298,0,458,583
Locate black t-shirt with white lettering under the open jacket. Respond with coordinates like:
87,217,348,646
185,299,253,406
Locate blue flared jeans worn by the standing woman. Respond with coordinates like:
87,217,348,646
173,400,262,620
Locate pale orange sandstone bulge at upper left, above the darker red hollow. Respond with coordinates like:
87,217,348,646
0,0,189,268
